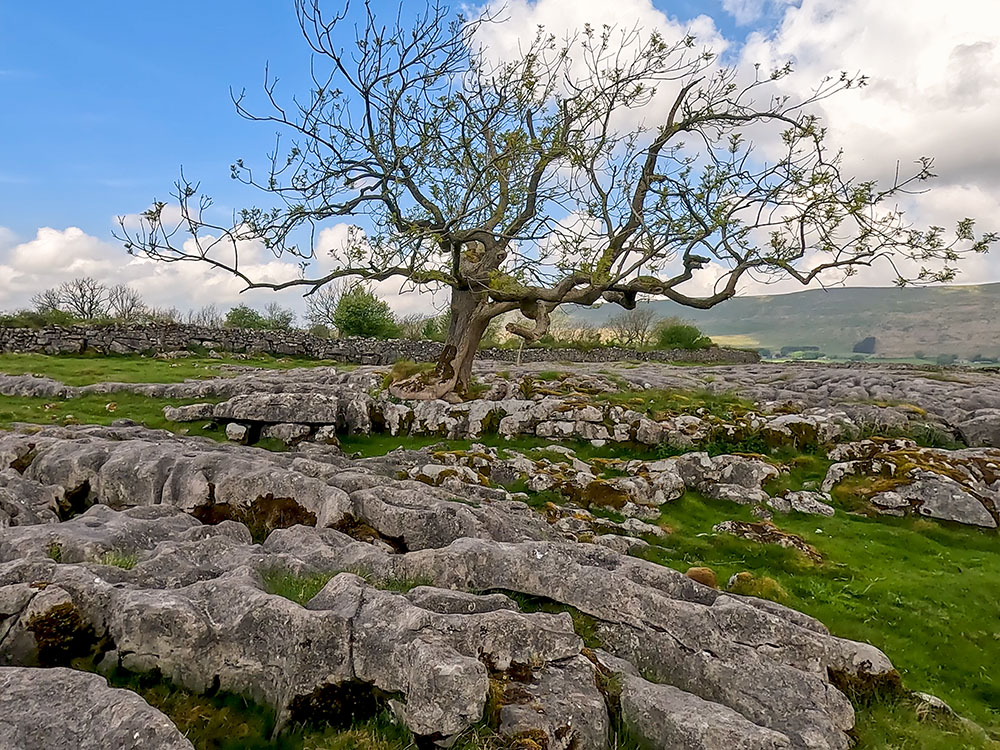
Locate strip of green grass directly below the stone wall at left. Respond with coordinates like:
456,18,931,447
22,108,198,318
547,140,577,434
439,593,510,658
0,354,330,385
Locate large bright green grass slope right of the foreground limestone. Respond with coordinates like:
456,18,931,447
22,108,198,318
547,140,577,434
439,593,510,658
639,493,1000,748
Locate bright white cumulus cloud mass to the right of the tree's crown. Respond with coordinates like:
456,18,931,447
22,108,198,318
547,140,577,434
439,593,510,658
741,0,1000,284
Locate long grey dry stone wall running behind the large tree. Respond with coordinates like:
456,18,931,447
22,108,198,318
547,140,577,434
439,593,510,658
0,325,760,365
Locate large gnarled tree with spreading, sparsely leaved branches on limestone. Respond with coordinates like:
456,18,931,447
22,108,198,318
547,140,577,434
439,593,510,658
118,0,996,398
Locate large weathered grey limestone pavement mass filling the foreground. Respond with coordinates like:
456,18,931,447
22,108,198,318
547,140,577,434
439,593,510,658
0,426,895,750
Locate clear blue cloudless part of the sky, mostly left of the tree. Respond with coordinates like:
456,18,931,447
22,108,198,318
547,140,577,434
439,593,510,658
0,0,764,239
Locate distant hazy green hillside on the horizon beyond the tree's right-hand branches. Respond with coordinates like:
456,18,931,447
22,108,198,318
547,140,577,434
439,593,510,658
566,283,1000,358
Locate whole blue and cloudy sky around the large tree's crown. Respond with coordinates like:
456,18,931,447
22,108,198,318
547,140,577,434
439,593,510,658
0,0,1000,314
